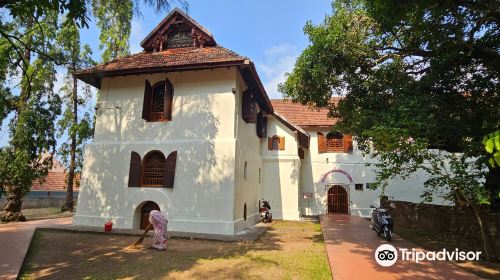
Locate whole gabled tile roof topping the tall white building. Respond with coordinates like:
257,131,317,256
74,9,273,113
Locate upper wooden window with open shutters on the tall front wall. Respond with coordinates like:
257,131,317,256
142,79,174,122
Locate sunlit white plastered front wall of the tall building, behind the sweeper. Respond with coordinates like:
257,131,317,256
74,68,244,234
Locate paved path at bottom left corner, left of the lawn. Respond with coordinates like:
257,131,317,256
0,217,73,280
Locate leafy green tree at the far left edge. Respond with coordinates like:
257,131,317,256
0,10,61,221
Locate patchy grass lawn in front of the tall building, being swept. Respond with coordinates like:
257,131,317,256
21,221,331,280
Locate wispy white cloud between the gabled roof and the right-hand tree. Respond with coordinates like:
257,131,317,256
256,43,299,98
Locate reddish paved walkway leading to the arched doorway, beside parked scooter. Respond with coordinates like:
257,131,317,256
320,214,480,280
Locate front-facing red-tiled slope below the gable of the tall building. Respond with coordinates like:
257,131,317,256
77,46,248,77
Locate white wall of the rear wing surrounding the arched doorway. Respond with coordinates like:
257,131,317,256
300,129,446,217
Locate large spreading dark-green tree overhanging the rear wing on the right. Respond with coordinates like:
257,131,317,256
279,0,500,258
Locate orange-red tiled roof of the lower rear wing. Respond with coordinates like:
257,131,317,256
271,97,340,128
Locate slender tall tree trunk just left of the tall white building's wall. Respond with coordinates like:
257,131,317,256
61,73,78,212
